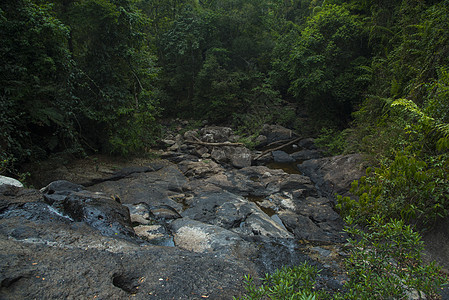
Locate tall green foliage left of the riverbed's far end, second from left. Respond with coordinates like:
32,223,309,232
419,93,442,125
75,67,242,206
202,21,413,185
68,0,159,154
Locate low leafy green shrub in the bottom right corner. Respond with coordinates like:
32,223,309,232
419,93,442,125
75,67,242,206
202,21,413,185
342,217,447,299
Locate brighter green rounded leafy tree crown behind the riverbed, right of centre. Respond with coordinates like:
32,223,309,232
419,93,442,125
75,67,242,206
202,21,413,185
283,5,368,126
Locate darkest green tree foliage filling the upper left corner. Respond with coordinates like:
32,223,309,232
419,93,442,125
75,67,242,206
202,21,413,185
0,0,76,162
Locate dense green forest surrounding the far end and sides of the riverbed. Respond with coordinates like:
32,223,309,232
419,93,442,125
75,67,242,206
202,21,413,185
0,0,449,297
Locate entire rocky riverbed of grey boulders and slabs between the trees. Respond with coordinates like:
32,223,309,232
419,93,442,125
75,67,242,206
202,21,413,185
0,126,412,299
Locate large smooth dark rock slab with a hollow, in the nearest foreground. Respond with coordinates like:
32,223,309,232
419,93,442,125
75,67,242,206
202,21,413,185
0,219,252,300
